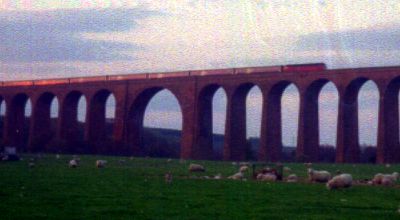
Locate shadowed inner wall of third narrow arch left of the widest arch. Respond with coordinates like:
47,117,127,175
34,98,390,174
29,92,57,152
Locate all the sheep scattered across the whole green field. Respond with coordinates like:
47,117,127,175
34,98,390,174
28,155,399,189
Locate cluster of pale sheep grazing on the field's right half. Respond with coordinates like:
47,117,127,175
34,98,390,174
189,163,399,190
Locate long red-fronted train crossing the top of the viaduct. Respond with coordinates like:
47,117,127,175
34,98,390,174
0,63,326,87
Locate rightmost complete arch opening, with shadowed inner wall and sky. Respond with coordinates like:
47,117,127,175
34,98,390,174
336,77,379,163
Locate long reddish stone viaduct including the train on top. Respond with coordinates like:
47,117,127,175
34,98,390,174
0,64,400,163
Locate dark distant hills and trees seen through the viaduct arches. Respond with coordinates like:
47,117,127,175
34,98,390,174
0,116,376,163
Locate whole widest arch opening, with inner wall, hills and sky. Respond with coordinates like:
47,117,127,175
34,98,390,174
128,87,183,158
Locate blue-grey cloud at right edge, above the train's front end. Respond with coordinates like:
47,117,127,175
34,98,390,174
295,25,400,51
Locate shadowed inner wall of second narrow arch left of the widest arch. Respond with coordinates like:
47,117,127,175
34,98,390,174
60,90,86,153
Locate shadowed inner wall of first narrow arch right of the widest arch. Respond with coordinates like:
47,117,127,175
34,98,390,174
193,84,226,159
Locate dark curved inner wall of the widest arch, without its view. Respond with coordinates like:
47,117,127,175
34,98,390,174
127,87,184,157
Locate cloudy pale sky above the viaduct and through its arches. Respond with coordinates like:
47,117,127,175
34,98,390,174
0,0,400,145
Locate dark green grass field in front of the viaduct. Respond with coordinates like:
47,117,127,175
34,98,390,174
0,155,400,219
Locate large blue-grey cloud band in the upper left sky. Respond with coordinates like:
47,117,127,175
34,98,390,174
0,9,161,62
